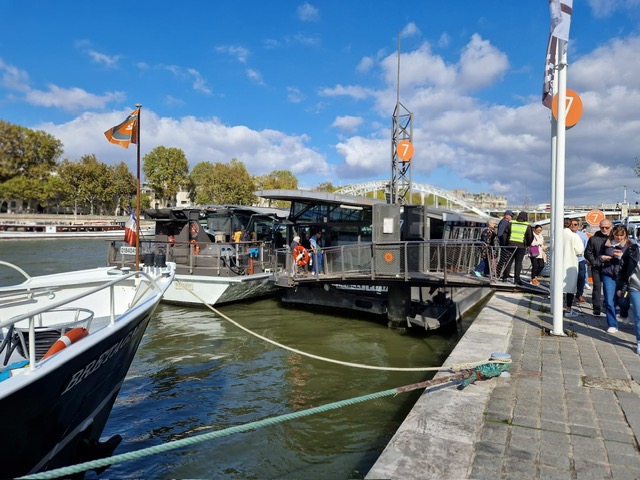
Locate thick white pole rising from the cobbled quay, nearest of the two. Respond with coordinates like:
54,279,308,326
551,39,567,336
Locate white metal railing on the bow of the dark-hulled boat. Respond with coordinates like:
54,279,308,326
0,269,169,370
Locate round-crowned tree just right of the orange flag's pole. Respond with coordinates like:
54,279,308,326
142,146,189,205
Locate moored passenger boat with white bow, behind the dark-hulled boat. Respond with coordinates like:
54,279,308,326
109,205,288,305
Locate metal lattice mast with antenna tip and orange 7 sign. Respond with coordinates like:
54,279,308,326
387,33,413,204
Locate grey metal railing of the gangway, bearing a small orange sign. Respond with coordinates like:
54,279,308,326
277,240,513,284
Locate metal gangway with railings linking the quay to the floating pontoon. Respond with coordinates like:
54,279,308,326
275,240,541,292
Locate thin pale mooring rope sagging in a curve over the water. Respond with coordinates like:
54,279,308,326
180,279,511,372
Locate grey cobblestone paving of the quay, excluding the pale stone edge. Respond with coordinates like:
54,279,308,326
470,296,640,479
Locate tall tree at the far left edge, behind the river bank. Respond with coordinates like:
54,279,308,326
0,120,62,182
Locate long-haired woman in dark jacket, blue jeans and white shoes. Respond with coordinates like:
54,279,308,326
600,225,631,333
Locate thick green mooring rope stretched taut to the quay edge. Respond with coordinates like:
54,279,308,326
19,363,511,479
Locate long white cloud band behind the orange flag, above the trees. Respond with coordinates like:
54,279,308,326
34,107,330,181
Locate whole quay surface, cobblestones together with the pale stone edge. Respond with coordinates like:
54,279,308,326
366,292,640,480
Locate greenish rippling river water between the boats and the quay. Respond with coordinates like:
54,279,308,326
0,240,470,479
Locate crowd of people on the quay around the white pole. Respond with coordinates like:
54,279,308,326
484,210,640,354
